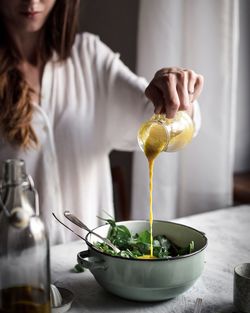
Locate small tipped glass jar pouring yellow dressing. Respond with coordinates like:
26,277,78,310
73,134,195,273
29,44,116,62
137,111,194,155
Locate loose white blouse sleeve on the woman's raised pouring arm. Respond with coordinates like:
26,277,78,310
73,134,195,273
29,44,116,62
90,37,154,151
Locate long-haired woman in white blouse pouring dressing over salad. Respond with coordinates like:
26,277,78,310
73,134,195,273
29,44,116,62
0,0,203,244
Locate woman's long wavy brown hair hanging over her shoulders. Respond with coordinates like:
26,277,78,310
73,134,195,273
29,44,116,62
0,0,80,149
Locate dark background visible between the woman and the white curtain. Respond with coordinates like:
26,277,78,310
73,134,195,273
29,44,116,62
79,0,139,220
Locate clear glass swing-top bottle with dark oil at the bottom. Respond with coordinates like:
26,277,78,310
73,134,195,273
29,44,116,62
0,160,51,313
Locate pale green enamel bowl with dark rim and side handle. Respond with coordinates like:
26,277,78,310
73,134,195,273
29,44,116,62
77,220,207,301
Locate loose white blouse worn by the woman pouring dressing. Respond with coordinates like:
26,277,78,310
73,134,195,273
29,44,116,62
0,33,199,244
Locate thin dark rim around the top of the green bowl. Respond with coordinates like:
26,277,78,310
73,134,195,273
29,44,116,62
85,220,208,262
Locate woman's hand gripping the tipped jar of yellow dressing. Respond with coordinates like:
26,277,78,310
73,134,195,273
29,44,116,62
145,67,203,118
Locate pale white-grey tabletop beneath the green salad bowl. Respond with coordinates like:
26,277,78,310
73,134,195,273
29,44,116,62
51,205,250,313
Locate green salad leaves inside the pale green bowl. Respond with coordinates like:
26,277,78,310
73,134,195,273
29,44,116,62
94,219,194,259
